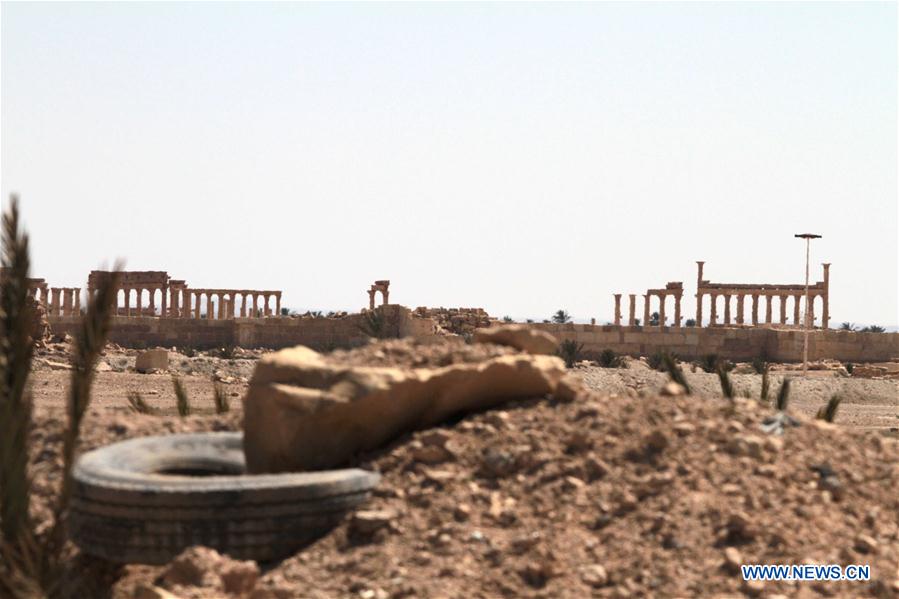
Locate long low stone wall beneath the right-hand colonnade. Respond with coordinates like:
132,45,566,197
532,324,899,362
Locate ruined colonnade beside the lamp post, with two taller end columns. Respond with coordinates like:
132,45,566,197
614,261,830,329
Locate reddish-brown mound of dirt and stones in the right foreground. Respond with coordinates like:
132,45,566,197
116,394,899,599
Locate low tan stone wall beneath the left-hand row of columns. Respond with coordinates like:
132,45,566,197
50,305,435,350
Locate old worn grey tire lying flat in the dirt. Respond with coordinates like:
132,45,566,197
69,433,380,564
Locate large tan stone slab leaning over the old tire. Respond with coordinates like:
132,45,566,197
243,346,565,473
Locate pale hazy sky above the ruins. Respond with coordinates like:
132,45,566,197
0,2,899,324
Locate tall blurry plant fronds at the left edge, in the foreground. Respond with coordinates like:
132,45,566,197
0,196,119,597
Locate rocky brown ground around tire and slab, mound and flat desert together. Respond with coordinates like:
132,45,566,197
19,341,899,599
